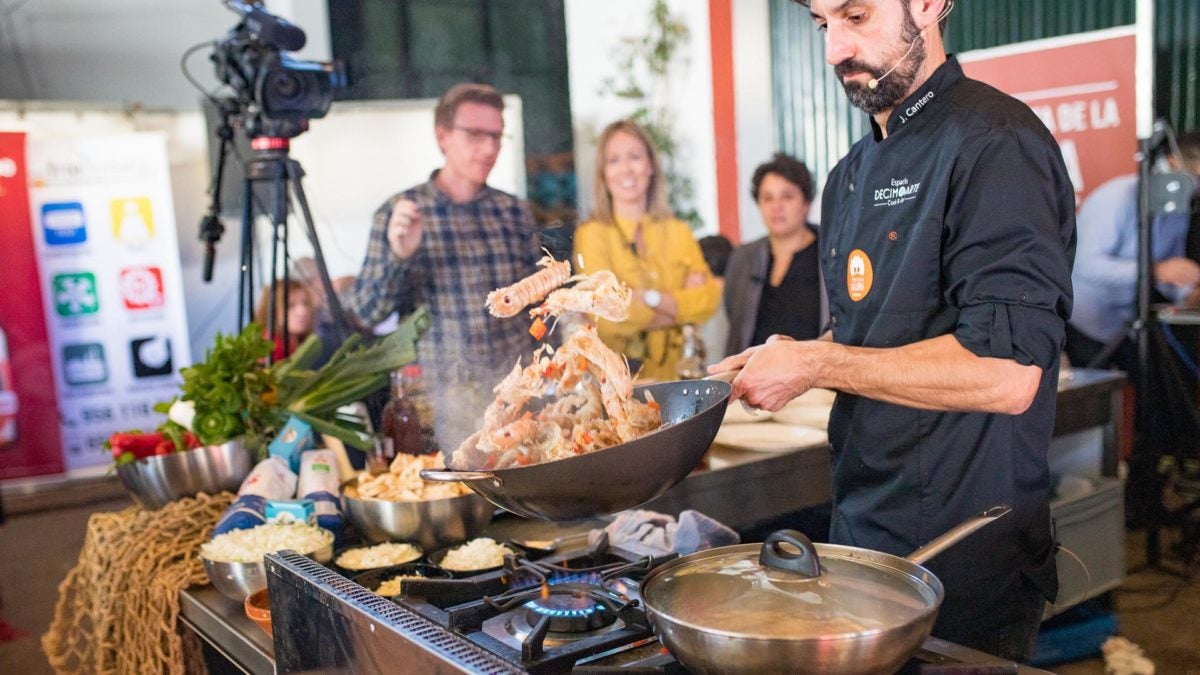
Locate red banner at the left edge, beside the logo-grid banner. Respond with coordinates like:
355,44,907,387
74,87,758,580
0,132,64,478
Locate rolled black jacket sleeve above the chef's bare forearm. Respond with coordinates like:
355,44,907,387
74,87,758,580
944,129,1075,369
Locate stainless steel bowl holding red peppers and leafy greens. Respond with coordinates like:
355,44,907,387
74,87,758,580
116,440,251,510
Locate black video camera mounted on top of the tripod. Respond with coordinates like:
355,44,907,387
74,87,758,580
211,0,346,138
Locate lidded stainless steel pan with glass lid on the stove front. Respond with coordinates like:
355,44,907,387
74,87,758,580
641,507,1012,675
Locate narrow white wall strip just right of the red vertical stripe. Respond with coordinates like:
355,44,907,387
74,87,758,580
733,0,779,241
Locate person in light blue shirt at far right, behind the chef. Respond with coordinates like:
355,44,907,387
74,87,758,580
1067,131,1200,372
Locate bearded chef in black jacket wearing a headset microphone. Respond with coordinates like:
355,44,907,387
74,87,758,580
710,0,1075,661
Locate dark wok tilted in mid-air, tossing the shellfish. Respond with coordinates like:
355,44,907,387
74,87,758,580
421,372,734,520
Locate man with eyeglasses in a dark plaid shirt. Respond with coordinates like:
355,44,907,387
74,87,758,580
344,83,541,452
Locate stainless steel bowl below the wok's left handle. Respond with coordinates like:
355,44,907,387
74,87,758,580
342,486,496,551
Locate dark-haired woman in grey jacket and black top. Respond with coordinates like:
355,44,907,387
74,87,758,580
725,154,829,354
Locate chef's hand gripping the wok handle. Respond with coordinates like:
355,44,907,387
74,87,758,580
708,335,821,412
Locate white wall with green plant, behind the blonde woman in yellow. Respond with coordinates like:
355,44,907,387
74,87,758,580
566,0,715,235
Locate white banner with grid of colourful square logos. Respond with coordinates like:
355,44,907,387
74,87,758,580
26,132,191,470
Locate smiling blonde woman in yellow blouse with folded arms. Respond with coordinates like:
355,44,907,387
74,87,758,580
574,120,721,380
